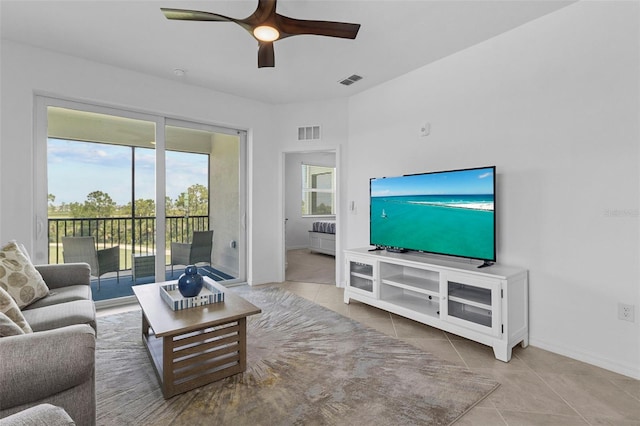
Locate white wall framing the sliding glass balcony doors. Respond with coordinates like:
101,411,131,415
0,40,280,284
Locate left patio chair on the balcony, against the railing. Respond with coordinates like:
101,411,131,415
62,237,120,291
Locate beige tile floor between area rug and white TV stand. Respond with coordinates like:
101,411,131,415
100,251,640,426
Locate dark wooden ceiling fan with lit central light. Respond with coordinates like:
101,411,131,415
161,0,360,68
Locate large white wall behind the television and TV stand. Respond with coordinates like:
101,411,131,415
346,2,640,377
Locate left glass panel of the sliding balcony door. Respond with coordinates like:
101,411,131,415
46,106,156,300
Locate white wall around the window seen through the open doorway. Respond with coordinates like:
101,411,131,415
284,151,336,250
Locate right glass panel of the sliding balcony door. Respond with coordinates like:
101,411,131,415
166,122,245,284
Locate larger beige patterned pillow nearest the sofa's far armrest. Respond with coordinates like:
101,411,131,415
0,241,49,309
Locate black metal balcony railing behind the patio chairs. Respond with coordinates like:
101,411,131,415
49,216,209,270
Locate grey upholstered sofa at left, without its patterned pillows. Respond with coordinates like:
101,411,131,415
0,260,97,426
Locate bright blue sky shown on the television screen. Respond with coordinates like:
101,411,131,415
371,168,493,197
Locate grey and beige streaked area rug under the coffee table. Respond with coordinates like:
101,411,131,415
96,287,499,426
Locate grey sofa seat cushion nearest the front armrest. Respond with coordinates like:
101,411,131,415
22,300,96,331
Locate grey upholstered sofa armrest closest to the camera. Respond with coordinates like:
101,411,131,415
0,324,96,410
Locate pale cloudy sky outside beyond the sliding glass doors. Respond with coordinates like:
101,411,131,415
47,139,208,205
